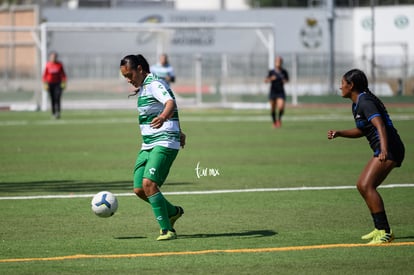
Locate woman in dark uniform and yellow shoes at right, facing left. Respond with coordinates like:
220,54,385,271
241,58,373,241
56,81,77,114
328,69,405,244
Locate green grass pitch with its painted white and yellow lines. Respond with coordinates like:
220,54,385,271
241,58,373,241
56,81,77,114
0,105,414,274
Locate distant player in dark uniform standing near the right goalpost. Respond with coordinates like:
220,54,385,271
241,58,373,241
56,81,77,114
265,56,289,128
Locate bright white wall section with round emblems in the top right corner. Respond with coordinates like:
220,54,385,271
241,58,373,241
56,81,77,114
353,6,414,76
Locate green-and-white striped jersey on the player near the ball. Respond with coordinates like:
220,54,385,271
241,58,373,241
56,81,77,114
137,73,180,150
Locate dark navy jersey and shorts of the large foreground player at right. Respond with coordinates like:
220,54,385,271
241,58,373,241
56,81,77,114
352,93,404,164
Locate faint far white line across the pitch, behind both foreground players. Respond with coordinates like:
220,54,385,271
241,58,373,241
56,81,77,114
0,114,414,127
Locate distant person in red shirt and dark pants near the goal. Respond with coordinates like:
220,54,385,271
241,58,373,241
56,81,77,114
43,52,66,119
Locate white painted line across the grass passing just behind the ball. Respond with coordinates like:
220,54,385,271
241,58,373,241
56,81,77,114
0,183,414,200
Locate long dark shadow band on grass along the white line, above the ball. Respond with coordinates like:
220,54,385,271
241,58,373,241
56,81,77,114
0,180,192,194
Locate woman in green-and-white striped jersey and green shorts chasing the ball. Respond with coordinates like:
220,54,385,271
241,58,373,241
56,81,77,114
120,55,186,241
